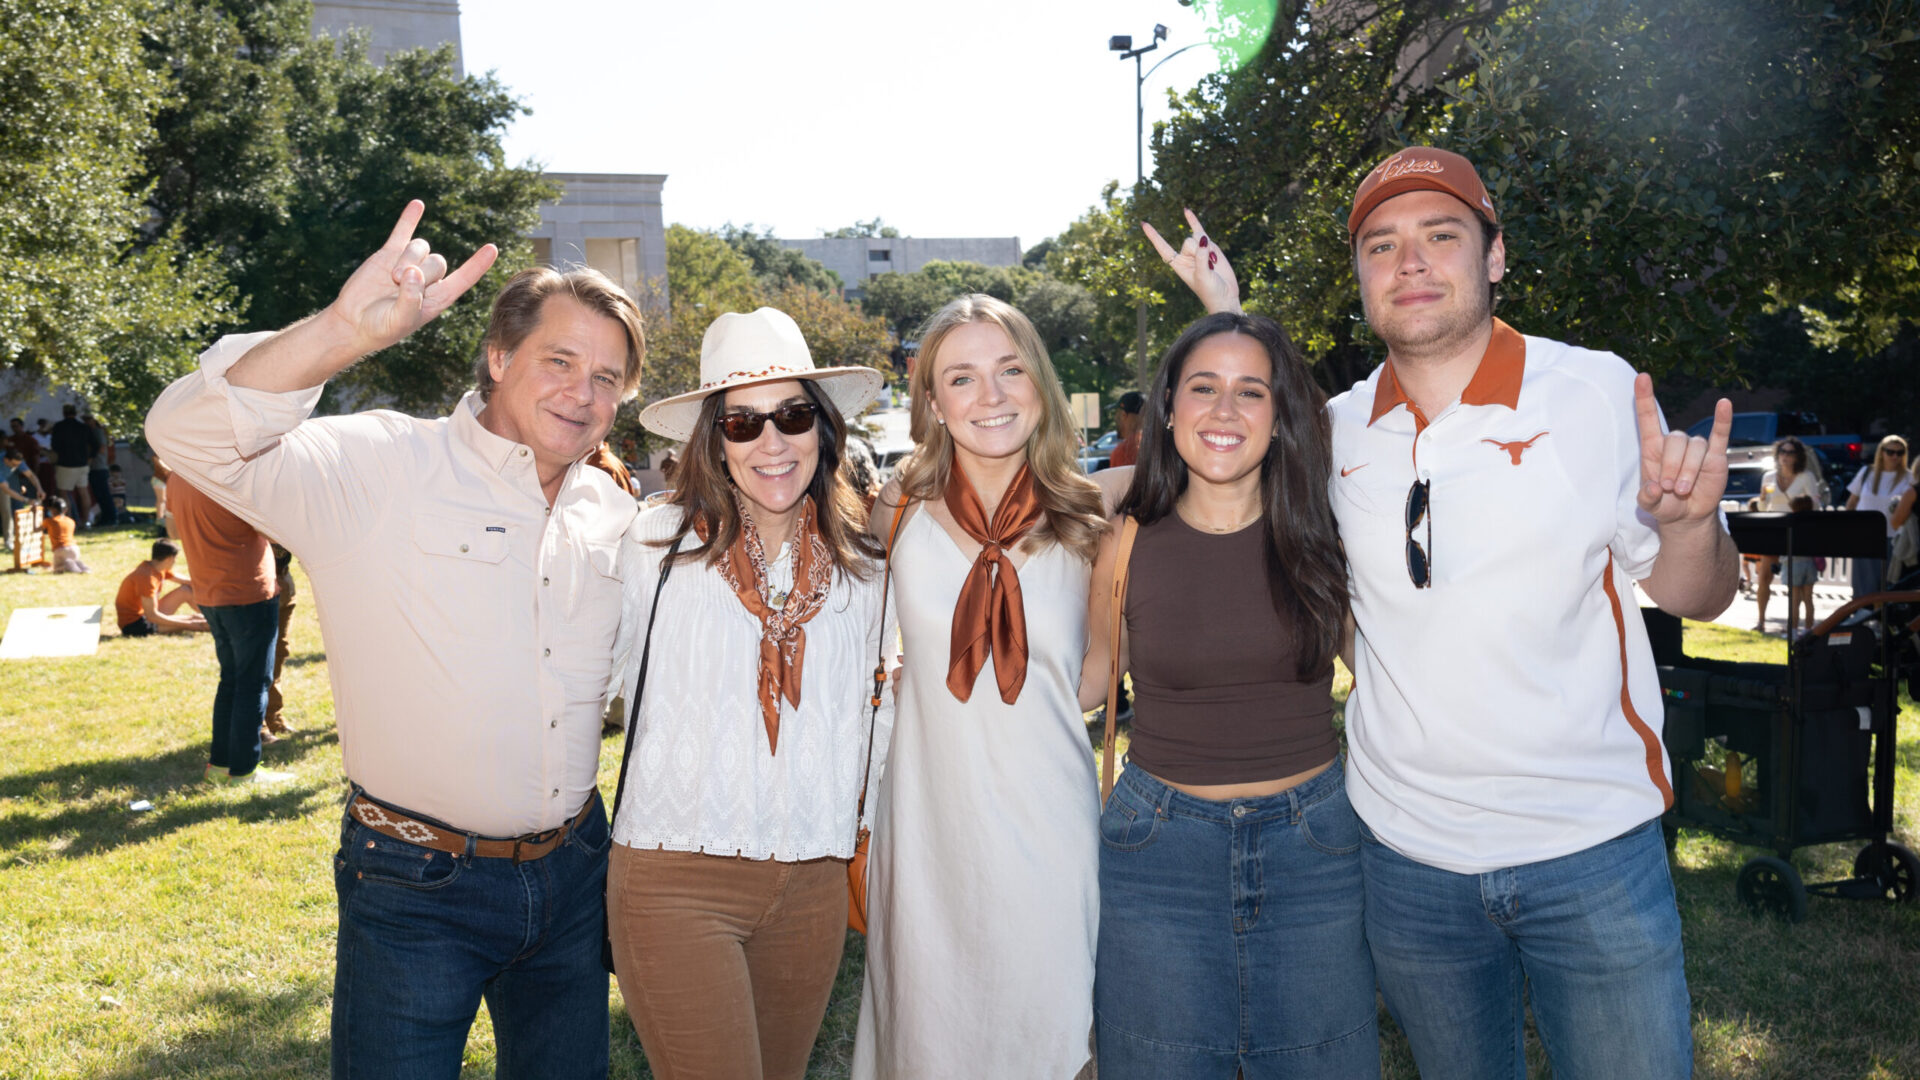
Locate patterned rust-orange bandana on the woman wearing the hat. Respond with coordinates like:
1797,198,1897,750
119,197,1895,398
695,500,833,753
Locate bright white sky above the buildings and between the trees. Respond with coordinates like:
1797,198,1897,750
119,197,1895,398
461,0,1219,248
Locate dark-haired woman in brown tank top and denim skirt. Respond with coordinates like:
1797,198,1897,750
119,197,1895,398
1083,313,1380,1080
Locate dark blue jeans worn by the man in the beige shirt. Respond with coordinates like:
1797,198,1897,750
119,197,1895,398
332,787,609,1080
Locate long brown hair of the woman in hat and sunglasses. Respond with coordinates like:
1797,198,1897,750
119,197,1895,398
657,379,881,580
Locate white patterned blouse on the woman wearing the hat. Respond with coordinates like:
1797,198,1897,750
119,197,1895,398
614,505,895,863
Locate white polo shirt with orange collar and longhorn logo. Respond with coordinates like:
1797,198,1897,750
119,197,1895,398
1329,319,1672,874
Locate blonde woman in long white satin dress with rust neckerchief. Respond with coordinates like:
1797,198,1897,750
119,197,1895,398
852,296,1131,1080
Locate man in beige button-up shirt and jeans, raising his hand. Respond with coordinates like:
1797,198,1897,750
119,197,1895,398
146,202,645,1080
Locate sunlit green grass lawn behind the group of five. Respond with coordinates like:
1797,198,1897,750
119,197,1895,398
0,530,1920,1080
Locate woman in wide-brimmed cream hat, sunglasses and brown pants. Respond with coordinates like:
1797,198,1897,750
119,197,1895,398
607,307,893,1080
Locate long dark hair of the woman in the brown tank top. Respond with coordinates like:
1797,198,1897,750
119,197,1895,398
1119,311,1348,680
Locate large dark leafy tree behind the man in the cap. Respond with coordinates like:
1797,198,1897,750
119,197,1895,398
1105,0,1920,388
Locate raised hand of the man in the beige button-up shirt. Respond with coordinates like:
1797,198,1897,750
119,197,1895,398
328,200,499,356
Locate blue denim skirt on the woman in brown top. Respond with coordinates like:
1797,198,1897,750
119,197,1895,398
1092,761,1380,1080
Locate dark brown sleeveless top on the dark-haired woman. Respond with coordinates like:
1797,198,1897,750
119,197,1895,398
1127,513,1340,784
